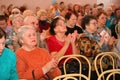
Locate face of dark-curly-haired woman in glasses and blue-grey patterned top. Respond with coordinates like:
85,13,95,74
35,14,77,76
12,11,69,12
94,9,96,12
86,19,98,33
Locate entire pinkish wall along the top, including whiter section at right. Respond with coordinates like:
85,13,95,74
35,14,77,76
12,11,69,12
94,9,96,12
0,0,120,9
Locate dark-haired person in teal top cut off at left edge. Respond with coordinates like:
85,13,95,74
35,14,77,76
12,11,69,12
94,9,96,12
0,28,18,80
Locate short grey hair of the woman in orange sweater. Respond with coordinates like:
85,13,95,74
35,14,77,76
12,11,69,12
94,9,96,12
17,25,35,39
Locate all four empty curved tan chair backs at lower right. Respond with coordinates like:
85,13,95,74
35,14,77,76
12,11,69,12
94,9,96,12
53,52,120,80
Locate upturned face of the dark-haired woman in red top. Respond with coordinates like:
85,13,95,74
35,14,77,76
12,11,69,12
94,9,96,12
54,19,67,33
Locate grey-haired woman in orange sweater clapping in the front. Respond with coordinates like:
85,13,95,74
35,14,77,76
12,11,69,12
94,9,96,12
16,25,61,80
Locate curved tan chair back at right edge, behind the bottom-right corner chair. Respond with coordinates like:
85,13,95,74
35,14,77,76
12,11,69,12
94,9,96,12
94,52,120,79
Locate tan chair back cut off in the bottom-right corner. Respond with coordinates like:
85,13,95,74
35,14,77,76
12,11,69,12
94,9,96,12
98,69,120,80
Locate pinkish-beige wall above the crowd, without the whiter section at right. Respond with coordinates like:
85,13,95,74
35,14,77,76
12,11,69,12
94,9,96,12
0,0,96,9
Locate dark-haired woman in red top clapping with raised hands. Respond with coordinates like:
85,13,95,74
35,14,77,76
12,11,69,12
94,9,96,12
46,17,77,73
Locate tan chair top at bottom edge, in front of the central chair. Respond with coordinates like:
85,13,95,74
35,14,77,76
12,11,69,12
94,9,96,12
53,74,90,80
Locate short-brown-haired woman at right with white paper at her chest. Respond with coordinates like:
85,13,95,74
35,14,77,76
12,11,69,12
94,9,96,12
97,12,115,52
